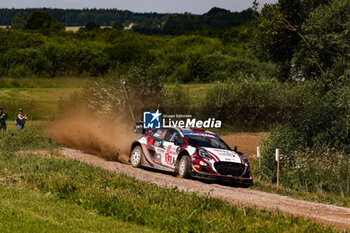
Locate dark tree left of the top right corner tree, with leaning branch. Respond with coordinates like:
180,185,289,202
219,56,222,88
252,0,330,80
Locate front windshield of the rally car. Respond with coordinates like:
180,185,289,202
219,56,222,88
185,135,230,150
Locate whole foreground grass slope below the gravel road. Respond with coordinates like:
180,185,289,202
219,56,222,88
0,153,336,232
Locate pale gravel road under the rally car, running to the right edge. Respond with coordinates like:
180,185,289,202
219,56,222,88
61,148,350,229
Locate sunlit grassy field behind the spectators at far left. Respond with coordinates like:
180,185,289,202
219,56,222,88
0,78,93,117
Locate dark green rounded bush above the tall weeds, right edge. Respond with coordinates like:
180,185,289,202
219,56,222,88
267,82,350,154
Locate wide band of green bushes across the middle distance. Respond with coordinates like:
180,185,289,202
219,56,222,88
0,25,274,80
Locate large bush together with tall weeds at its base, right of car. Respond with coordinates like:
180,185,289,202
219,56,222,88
260,82,350,196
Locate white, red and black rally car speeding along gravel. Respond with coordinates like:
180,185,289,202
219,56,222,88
130,127,253,186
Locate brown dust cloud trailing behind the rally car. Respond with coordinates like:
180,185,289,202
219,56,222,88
46,110,137,163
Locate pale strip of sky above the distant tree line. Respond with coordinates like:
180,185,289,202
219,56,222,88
0,0,277,14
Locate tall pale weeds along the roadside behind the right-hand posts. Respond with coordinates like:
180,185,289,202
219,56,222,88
257,145,350,197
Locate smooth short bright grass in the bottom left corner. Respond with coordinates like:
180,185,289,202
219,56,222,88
0,184,154,233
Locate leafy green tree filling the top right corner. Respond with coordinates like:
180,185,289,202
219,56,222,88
295,0,350,80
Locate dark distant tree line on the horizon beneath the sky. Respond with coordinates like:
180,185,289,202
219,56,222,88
0,7,253,35
